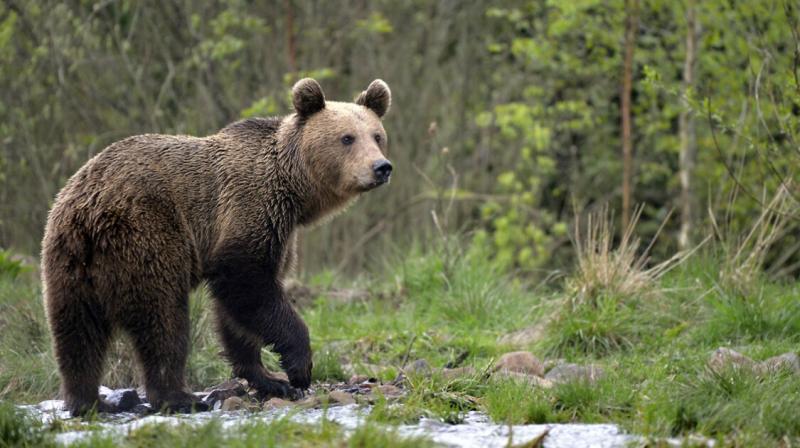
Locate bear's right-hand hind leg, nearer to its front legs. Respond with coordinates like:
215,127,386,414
125,296,208,412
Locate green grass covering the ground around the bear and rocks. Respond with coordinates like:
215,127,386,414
0,243,800,447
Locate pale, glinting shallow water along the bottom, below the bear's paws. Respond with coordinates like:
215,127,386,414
23,400,640,448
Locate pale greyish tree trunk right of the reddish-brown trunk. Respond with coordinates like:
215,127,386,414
678,0,697,250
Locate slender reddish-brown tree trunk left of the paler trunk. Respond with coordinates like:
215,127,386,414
622,0,639,231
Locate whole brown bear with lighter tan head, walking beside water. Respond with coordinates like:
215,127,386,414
42,79,392,415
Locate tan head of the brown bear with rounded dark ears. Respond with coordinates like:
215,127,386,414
292,78,392,200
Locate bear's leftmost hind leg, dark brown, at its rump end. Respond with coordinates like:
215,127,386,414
47,298,116,417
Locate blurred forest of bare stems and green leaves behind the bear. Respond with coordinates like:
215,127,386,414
0,0,800,276
